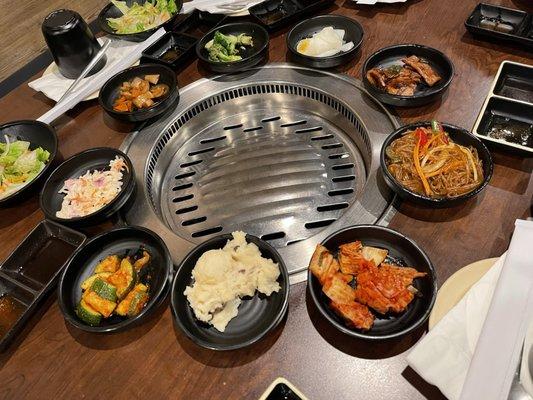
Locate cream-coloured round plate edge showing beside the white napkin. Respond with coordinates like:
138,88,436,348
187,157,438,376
429,257,498,330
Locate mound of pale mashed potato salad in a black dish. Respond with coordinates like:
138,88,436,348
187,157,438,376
184,232,280,332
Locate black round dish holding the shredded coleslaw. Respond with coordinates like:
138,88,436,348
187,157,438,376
39,147,135,227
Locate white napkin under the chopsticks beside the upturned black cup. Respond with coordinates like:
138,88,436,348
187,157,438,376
28,38,138,101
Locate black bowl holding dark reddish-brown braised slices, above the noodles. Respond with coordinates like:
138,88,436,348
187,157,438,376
363,44,454,107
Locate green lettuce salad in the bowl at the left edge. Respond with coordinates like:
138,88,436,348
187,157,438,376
0,136,50,200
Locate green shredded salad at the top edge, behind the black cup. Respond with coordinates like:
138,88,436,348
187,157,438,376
107,0,178,34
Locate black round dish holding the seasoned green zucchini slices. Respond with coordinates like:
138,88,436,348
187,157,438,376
57,226,172,333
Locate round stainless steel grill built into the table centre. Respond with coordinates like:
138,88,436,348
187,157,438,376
119,64,397,282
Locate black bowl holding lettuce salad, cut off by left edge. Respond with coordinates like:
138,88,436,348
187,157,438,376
0,120,57,206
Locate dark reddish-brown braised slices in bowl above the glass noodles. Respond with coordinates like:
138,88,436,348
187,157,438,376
366,56,442,96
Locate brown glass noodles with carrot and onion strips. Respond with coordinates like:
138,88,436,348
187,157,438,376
385,121,484,198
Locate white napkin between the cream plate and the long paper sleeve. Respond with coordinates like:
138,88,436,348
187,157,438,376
407,254,506,400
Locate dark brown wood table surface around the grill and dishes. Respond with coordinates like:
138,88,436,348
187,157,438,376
0,0,533,400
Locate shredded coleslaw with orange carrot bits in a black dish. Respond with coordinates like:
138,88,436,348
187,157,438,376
56,156,128,219
